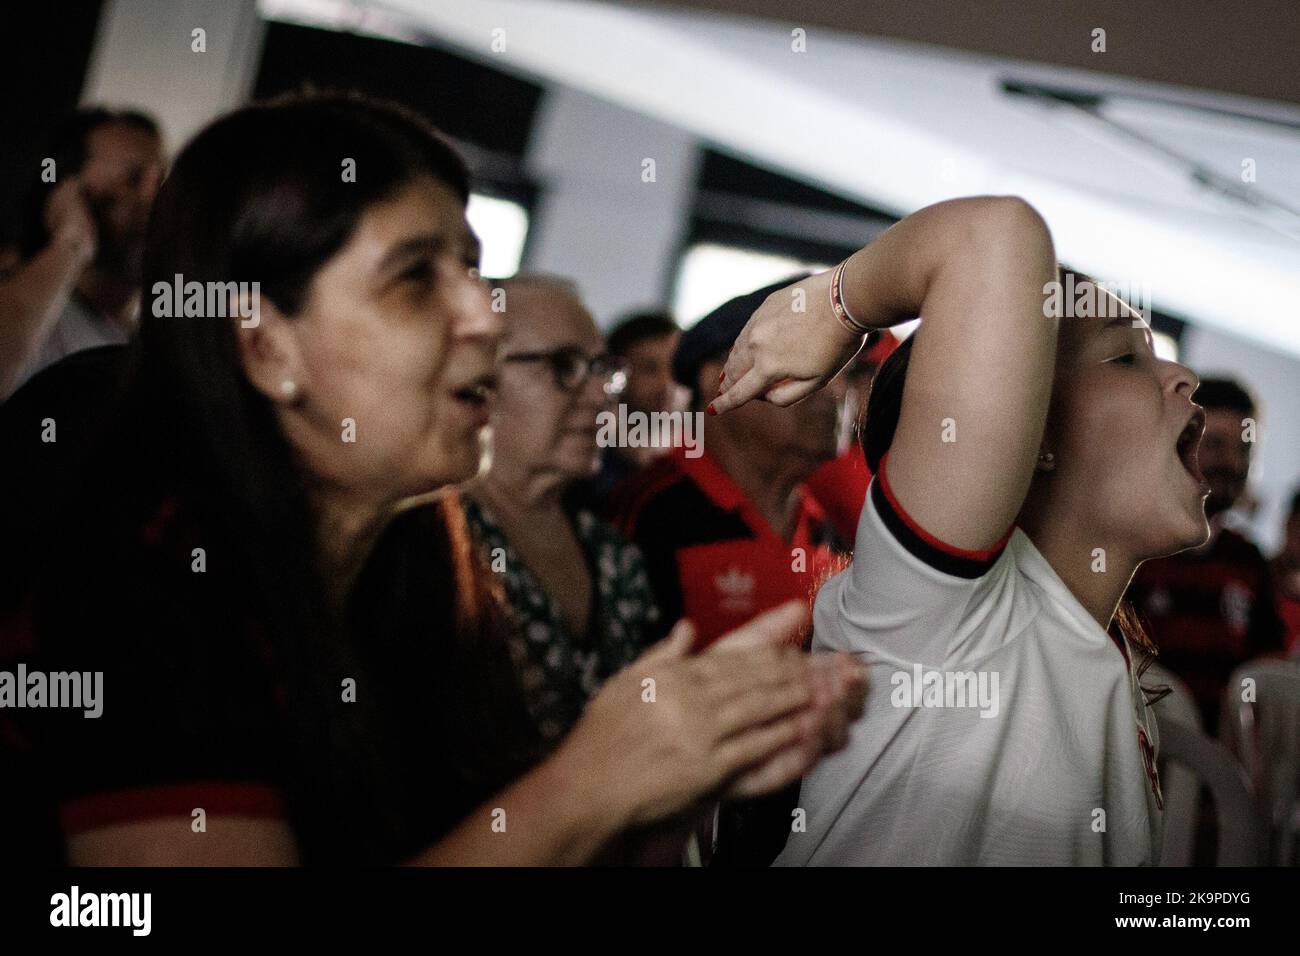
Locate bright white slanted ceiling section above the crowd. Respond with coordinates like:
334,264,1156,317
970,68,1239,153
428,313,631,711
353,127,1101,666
264,0,1300,356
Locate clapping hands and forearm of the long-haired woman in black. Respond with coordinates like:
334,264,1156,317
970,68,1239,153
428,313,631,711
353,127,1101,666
411,601,866,866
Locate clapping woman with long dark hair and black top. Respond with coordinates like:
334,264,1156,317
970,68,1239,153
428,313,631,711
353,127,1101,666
4,95,862,864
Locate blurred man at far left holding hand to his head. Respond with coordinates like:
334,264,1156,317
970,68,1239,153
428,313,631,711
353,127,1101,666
0,108,163,399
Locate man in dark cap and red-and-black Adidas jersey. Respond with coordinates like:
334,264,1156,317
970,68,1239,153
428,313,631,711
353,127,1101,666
611,277,845,866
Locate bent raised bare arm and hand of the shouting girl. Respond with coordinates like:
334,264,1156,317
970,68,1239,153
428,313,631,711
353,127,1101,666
714,196,1057,550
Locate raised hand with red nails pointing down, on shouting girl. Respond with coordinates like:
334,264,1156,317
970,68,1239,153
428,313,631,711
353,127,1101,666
710,271,865,414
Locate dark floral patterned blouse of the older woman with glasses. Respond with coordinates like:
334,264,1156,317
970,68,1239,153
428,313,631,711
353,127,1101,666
465,498,660,745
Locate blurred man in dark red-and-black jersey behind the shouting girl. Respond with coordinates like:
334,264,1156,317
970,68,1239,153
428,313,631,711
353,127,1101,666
1128,378,1283,734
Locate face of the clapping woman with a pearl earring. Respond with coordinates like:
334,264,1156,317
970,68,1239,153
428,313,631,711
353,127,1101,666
271,178,502,498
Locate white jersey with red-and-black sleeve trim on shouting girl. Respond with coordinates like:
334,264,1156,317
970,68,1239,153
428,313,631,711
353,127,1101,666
776,463,1162,866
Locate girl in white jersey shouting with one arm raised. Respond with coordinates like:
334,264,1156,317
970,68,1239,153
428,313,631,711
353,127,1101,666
712,198,1209,865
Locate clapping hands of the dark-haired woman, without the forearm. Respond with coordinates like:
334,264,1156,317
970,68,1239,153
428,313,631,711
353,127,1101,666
558,602,866,826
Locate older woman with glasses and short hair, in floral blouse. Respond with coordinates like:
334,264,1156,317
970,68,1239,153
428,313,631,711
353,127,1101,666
465,276,664,744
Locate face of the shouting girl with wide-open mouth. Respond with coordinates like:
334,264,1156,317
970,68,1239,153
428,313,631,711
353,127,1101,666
1044,312,1209,561
